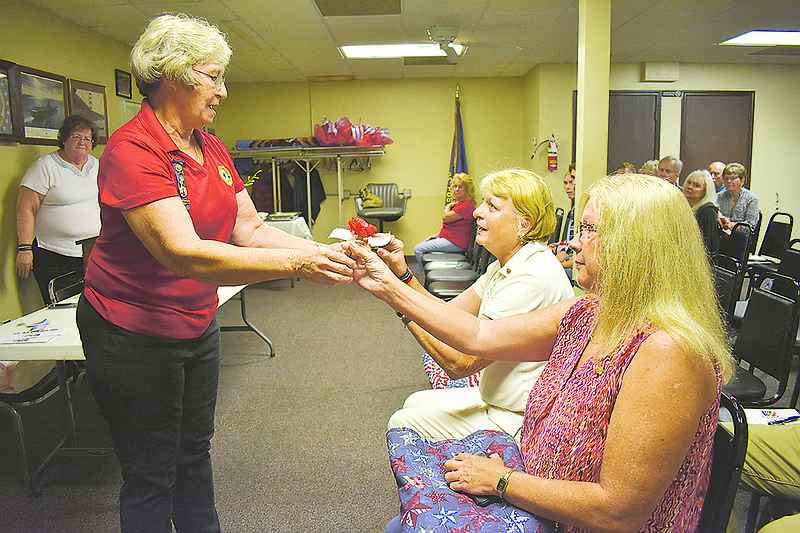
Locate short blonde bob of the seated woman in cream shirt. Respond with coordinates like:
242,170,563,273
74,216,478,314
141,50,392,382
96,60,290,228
481,168,556,241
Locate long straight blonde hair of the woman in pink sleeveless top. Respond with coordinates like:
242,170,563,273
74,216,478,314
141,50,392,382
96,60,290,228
583,174,733,380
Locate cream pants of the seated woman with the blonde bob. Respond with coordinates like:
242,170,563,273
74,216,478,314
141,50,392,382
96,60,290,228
389,387,522,443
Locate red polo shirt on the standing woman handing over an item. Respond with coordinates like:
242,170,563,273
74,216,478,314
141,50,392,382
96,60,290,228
84,100,244,339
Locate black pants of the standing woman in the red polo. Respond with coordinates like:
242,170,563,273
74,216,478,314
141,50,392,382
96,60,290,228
77,296,221,533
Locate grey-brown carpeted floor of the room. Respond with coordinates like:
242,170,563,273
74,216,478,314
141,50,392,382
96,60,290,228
0,268,791,533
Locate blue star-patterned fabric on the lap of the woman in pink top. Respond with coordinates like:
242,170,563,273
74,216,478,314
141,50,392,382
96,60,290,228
386,428,556,533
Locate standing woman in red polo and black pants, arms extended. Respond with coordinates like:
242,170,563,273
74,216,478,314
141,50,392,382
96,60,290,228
77,15,354,533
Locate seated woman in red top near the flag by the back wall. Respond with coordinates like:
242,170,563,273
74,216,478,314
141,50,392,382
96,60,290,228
414,173,475,270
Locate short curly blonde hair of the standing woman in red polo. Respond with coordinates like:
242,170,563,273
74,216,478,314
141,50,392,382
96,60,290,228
131,13,232,96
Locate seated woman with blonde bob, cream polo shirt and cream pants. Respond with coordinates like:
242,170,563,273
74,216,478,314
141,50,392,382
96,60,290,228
379,169,575,440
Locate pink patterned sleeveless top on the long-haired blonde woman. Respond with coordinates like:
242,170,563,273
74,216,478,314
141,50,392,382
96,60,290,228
522,297,722,533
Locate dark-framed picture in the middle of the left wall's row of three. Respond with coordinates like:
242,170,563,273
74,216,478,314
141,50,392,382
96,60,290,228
12,65,67,145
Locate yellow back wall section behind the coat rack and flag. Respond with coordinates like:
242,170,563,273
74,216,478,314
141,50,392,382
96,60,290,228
213,78,529,246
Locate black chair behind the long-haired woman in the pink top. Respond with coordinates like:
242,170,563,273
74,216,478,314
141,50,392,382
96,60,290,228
697,392,747,533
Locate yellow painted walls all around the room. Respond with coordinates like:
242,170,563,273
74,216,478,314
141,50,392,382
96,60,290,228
0,0,800,320
